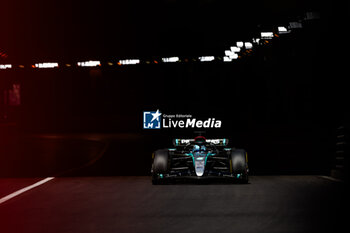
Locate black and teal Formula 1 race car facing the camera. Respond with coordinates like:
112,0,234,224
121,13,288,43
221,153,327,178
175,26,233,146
151,136,249,184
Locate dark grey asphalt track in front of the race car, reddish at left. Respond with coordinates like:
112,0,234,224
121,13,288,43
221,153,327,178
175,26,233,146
0,176,349,233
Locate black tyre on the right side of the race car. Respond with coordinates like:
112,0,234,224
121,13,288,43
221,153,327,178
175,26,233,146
231,149,248,184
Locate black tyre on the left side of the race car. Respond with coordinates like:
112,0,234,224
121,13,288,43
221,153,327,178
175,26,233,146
152,149,170,185
